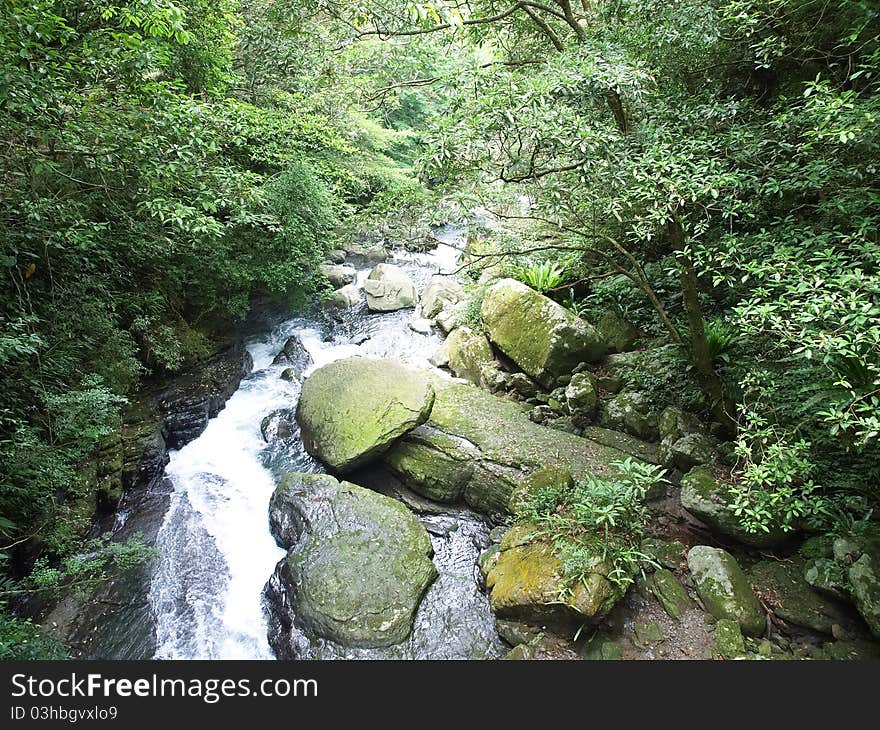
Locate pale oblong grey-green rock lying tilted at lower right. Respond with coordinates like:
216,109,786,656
687,545,766,636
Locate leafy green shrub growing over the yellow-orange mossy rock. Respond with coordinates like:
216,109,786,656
515,459,665,589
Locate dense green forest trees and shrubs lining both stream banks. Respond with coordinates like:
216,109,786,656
0,0,880,656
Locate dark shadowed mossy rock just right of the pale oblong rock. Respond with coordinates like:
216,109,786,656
749,558,847,634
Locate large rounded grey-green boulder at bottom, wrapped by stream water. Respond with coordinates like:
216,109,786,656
267,473,437,647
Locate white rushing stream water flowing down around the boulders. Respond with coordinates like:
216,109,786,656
149,227,502,659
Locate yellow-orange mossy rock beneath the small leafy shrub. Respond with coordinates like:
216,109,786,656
486,525,622,630
